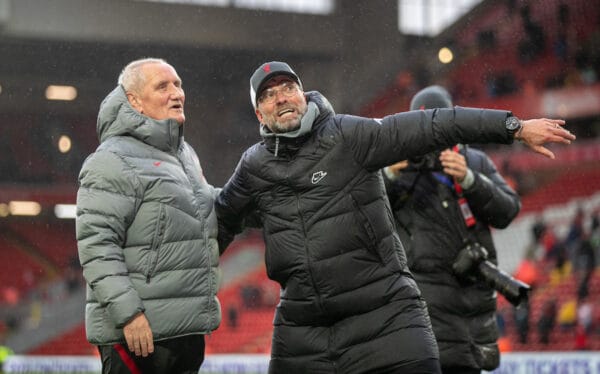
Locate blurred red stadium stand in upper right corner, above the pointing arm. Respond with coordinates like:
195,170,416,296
361,0,600,117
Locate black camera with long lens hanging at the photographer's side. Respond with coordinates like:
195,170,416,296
452,243,531,306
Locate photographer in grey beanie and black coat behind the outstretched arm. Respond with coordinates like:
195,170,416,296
384,86,527,374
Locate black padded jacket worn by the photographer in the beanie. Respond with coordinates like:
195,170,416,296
386,147,521,370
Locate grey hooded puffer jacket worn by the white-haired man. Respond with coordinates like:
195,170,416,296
76,86,221,345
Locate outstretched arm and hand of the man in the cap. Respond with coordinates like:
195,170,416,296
340,107,575,169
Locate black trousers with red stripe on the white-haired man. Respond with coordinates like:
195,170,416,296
98,335,204,374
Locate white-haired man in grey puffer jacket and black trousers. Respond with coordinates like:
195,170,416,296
76,58,221,373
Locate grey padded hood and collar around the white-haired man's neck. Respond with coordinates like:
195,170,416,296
96,85,183,151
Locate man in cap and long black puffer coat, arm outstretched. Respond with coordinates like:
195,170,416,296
215,61,575,374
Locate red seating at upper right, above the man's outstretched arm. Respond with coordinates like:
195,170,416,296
360,0,600,117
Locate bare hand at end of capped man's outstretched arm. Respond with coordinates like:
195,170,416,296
515,118,575,159
